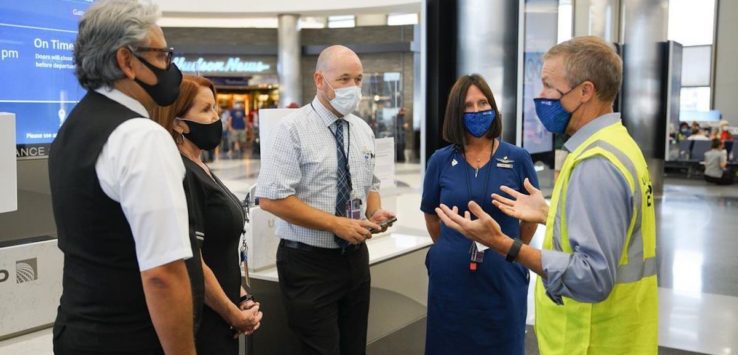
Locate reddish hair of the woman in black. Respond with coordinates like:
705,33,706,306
151,75,216,137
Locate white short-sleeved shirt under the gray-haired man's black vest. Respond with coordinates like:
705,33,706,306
95,89,192,271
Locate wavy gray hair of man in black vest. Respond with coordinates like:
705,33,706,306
74,0,159,90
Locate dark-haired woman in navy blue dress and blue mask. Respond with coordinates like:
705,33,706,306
420,74,538,354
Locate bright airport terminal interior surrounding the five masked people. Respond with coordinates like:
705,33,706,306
0,0,738,355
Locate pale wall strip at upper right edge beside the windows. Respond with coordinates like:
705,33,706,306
714,0,738,126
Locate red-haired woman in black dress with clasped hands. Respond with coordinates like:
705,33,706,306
153,75,262,355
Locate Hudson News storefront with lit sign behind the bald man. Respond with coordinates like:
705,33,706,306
164,26,420,161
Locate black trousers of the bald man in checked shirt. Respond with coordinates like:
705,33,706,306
277,244,371,355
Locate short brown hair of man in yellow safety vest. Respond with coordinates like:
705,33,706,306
543,36,623,102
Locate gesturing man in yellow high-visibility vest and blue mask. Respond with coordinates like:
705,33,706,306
436,37,658,355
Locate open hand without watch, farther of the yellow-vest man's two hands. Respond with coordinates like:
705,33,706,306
492,178,548,224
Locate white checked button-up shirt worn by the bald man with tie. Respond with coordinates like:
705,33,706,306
256,97,379,248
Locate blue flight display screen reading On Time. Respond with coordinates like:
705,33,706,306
0,0,92,158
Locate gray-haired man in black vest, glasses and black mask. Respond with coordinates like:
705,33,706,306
49,0,203,355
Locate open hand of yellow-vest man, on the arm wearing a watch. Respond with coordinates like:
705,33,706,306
436,201,507,249
